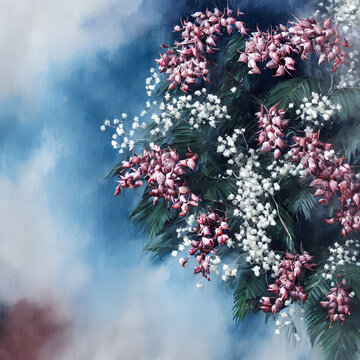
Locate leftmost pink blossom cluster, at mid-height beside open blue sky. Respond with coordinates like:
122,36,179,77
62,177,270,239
114,145,199,216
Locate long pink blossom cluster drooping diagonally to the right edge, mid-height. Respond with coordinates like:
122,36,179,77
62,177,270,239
292,131,360,237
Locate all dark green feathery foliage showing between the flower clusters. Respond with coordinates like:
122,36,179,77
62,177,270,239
106,14,360,360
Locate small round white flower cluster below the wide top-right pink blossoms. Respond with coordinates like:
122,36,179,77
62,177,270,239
296,92,341,127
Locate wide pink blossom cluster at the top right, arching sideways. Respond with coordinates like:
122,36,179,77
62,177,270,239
238,18,349,76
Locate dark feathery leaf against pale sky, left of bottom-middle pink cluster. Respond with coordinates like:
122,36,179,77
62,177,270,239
233,269,266,323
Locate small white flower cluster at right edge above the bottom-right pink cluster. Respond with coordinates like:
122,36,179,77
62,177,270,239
321,240,360,280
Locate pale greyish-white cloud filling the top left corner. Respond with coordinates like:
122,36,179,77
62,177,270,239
0,0,141,96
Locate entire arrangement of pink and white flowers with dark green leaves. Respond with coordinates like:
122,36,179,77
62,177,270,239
101,1,360,359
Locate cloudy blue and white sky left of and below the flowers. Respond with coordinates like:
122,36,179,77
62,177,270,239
0,0,318,360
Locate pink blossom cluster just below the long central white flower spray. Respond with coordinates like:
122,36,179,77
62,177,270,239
260,251,316,314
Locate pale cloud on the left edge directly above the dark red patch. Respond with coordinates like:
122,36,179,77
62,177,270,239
0,138,90,302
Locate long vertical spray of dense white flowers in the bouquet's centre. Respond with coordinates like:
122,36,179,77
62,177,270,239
217,139,280,276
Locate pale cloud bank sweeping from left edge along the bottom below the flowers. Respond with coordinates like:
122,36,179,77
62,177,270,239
0,137,320,360
